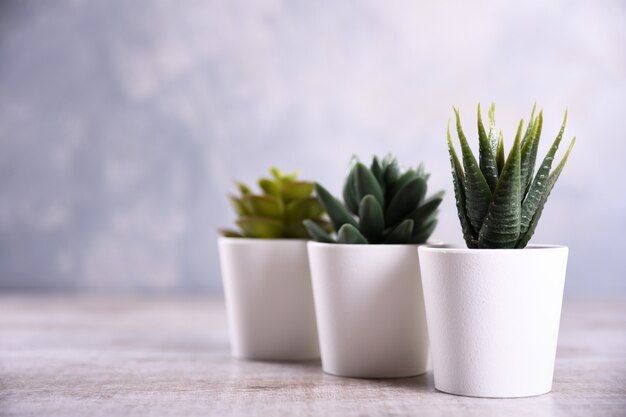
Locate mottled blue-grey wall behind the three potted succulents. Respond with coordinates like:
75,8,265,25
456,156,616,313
0,0,626,293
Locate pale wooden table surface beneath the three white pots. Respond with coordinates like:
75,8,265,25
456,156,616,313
0,295,626,417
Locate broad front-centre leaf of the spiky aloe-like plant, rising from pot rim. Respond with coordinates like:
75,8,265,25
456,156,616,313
478,120,524,249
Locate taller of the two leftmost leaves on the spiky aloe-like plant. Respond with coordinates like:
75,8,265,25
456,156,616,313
454,108,491,230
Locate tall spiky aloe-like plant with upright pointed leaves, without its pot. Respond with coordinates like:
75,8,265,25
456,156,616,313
448,104,576,249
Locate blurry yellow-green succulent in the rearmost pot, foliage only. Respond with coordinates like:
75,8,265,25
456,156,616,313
221,168,332,239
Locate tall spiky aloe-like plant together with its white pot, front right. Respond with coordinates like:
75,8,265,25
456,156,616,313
419,105,575,397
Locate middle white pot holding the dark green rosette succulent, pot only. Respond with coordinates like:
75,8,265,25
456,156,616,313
309,242,428,378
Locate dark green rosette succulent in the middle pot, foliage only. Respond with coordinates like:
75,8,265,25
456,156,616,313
304,155,443,244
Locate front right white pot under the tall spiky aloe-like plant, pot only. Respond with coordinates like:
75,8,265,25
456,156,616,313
419,246,568,398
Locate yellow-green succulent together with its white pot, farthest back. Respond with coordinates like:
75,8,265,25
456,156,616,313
219,168,332,361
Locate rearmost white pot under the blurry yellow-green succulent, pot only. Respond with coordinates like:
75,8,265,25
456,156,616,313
219,237,319,361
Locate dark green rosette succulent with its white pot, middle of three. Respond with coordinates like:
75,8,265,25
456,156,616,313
304,156,443,378
